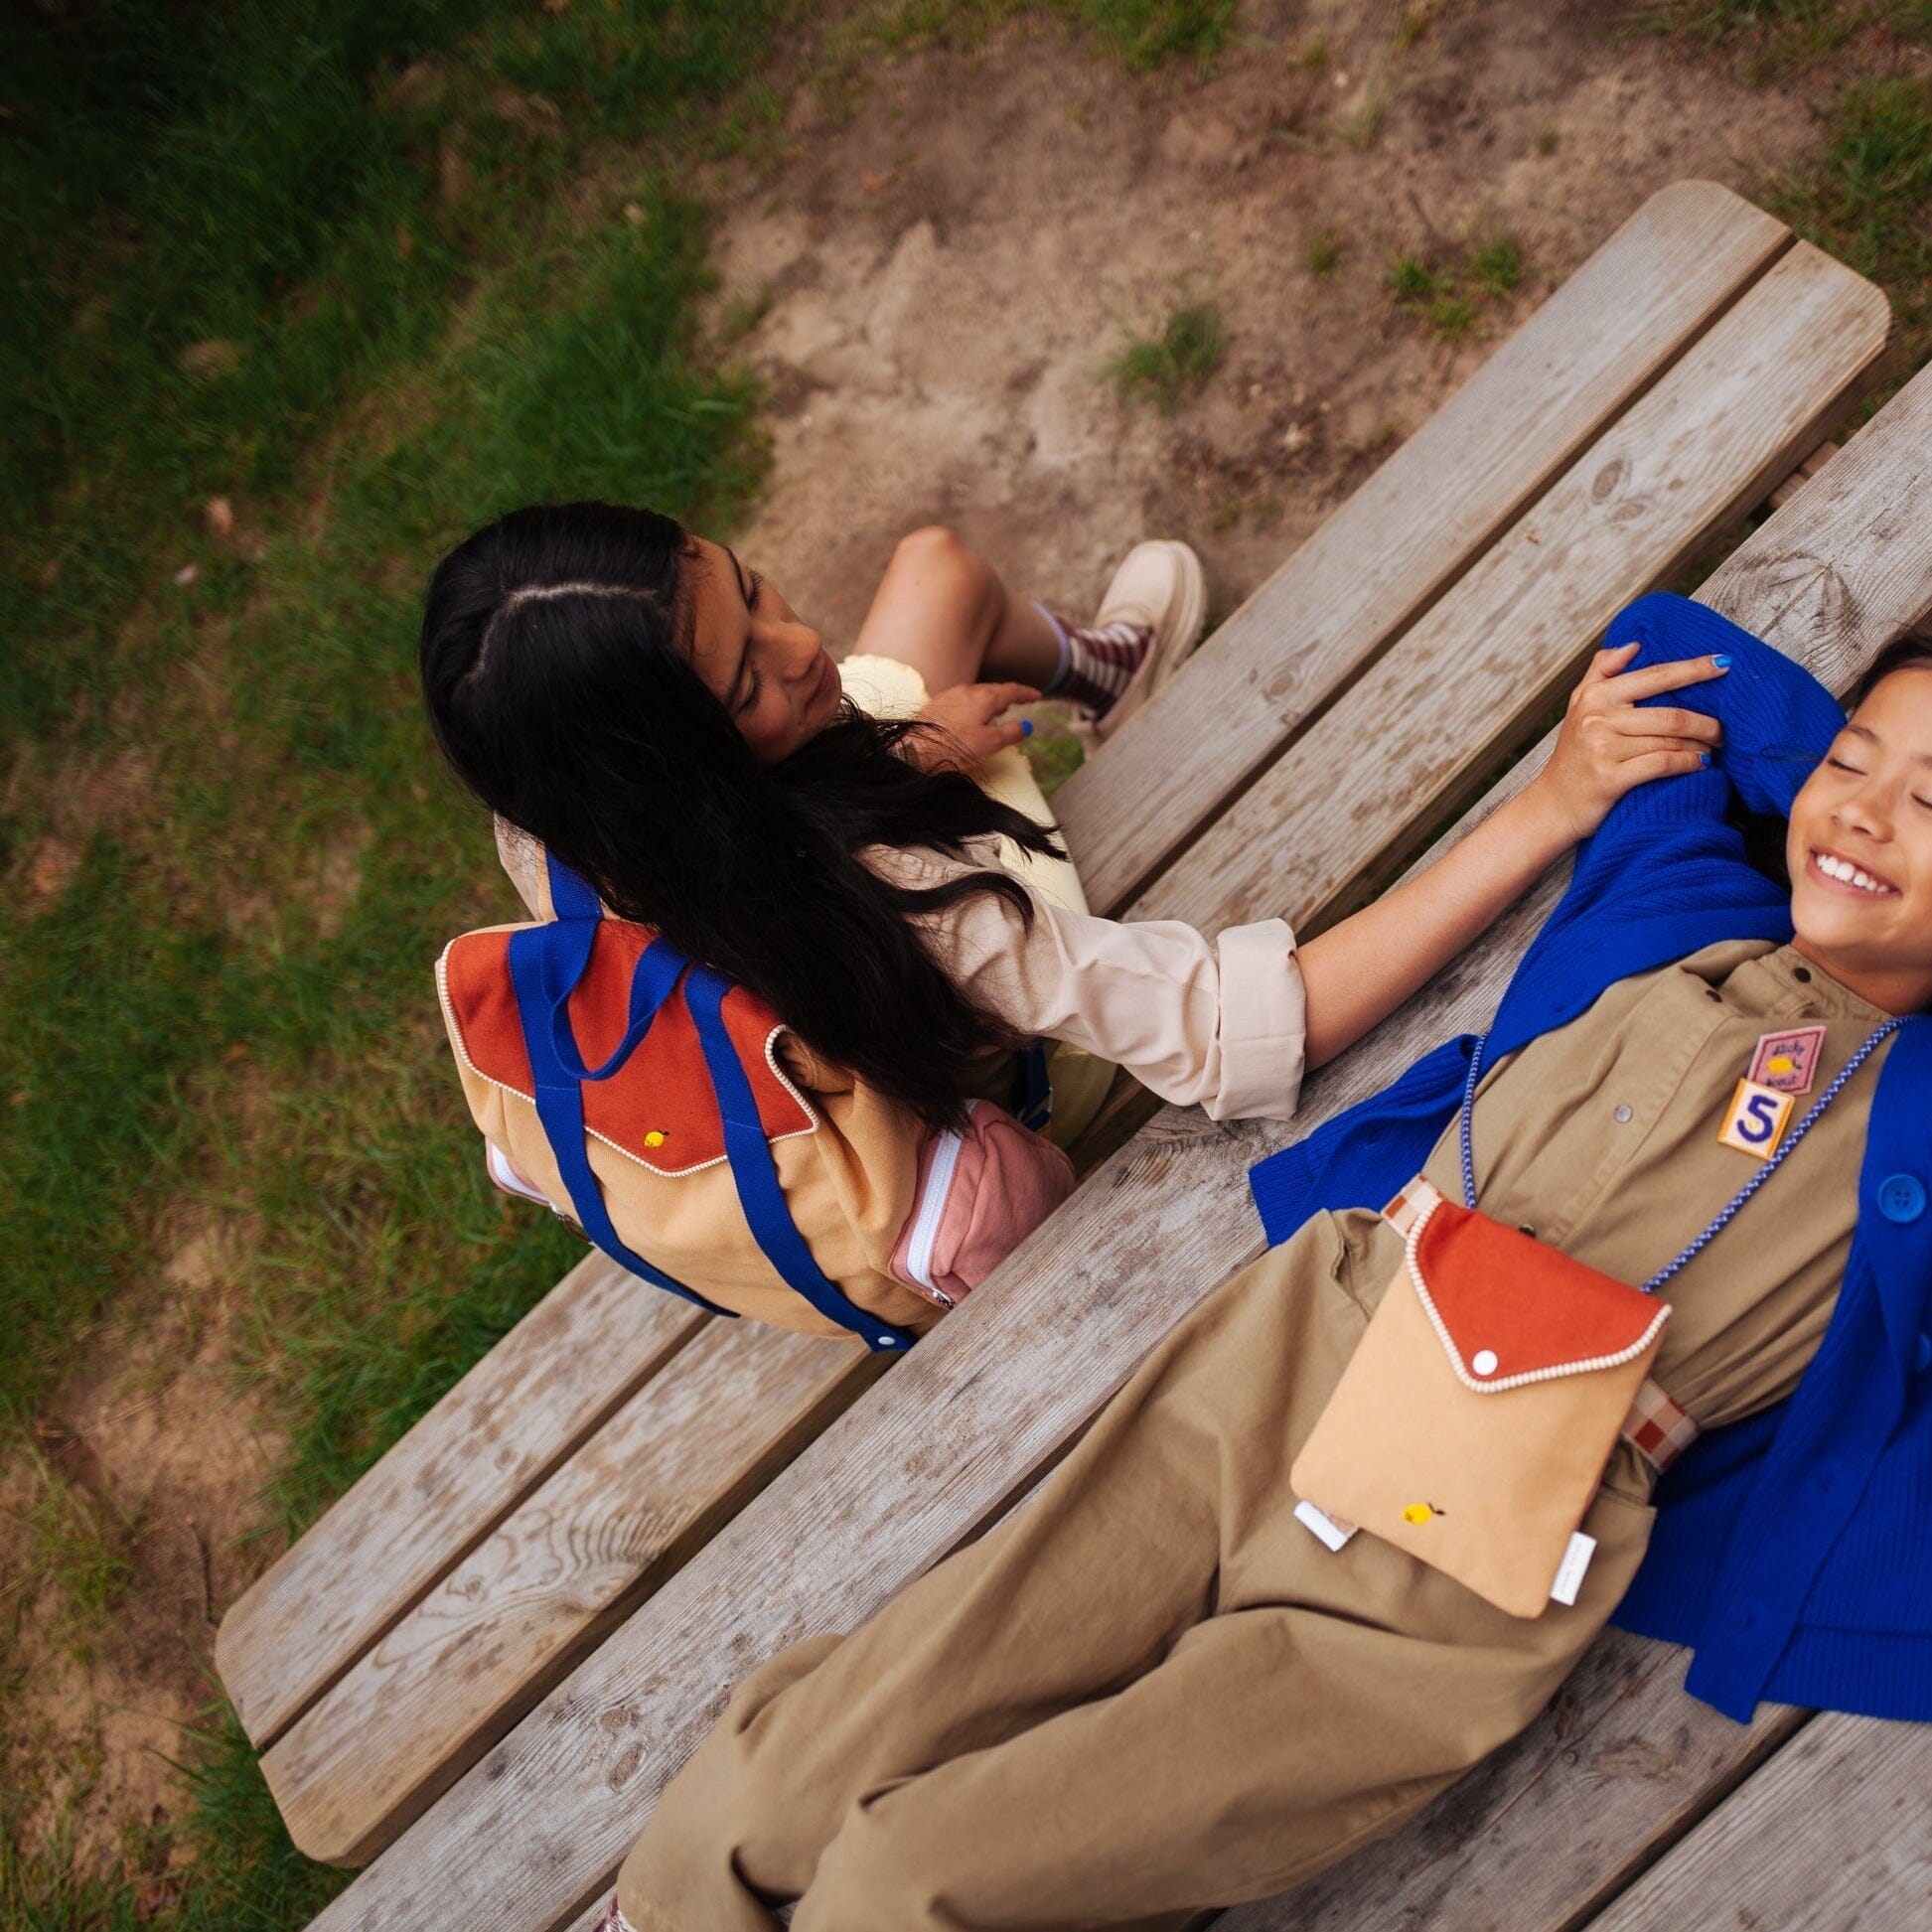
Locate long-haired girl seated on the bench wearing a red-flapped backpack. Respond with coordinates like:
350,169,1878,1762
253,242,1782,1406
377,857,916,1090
423,505,1717,1351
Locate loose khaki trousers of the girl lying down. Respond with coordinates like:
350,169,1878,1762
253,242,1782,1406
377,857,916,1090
618,1213,1650,1932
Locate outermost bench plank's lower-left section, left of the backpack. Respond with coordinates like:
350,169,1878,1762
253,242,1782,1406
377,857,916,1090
215,1254,711,1744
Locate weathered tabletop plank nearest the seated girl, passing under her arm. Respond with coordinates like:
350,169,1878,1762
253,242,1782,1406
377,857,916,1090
305,324,1932,1932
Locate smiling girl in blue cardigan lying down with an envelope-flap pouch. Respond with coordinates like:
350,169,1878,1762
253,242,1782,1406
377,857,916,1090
611,597,1932,1932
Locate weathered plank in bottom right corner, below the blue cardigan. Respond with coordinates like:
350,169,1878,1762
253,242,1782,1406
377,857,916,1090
1592,1713,1932,1932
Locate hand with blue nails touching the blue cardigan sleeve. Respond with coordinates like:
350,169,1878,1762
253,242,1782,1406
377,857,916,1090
1530,644,1731,840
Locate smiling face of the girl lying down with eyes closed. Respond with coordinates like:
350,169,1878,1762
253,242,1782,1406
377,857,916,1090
1785,665,1932,1012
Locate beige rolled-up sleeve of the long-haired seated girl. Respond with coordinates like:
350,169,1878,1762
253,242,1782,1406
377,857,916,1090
881,854,1308,1120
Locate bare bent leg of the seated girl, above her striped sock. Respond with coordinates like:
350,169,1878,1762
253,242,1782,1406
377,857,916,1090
852,523,1061,695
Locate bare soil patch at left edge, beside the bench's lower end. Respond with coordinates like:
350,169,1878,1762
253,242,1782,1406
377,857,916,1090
0,1215,280,1874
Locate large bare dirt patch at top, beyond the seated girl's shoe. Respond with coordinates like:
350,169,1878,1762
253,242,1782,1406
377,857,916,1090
715,0,1812,648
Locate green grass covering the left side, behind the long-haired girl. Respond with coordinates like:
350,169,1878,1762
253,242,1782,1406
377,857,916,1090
0,0,783,1928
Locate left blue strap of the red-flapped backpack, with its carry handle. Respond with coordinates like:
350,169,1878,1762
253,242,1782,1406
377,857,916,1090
510,860,734,1316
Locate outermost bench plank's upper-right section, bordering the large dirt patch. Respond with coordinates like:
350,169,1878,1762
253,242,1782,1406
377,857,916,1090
1053,182,1789,912
